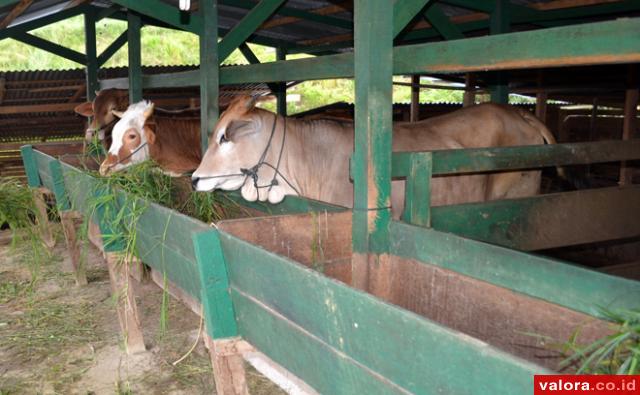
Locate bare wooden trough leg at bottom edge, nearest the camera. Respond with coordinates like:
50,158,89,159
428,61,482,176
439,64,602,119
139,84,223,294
204,335,249,395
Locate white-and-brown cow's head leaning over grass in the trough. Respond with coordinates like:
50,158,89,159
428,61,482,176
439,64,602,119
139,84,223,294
100,100,156,176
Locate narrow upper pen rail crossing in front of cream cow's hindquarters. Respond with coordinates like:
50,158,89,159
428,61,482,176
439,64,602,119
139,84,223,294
392,139,640,177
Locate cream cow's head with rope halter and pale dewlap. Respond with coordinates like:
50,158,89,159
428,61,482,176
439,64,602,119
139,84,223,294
192,96,290,203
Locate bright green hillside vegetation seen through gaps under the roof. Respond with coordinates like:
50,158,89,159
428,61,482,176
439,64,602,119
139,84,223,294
0,16,528,113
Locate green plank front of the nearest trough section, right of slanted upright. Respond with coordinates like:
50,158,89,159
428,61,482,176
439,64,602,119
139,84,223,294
220,232,545,394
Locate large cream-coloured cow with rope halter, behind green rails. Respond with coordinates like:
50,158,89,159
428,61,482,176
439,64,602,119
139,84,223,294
192,96,555,218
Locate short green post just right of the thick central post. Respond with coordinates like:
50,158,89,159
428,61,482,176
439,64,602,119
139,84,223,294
402,152,433,227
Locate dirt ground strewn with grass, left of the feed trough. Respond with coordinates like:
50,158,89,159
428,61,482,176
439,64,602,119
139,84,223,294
0,228,283,395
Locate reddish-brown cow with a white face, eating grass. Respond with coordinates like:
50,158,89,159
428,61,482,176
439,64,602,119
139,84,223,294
100,100,202,176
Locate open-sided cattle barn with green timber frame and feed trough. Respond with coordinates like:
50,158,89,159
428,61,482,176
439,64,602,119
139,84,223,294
0,0,640,395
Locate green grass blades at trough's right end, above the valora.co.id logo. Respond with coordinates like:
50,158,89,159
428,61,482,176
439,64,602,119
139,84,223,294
560,309,640,374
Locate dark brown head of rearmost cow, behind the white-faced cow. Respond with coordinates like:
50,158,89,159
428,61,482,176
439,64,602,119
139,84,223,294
75,89,129,144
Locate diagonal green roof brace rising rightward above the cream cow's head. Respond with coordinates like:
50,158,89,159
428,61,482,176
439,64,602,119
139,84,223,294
219,0,285,63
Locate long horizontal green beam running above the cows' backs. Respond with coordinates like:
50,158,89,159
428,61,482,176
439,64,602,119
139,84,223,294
100,18,640,88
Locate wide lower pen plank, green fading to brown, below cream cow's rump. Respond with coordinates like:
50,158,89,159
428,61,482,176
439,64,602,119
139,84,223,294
430,187,640,251
